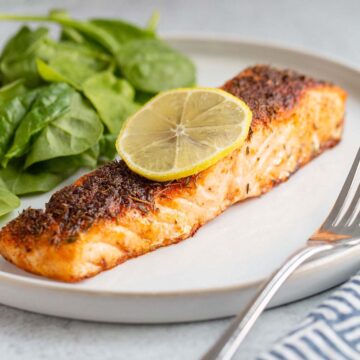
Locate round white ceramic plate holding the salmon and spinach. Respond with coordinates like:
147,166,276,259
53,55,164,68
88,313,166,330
0,37,360,323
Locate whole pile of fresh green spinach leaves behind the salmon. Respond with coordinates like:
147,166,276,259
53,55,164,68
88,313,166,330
0,11,195,216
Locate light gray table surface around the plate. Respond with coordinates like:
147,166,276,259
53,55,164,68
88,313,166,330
0,0,360,360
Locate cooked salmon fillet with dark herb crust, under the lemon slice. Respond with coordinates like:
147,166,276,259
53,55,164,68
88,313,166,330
0,66,346,282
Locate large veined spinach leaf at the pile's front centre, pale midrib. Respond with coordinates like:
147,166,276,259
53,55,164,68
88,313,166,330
25,91,103,168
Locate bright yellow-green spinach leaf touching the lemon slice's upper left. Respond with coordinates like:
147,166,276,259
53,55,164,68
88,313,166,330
83,71,139,134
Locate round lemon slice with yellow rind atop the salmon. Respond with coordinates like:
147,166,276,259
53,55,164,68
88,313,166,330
116,88,252,181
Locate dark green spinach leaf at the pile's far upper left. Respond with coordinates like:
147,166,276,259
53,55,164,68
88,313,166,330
0,26,48,87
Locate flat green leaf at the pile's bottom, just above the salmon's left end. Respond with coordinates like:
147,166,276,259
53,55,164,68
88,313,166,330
0,164,64,195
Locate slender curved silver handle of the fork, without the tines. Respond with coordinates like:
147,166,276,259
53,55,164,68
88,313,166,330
202,244,334,360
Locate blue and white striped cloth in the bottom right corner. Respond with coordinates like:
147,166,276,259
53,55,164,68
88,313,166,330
257,273,360,360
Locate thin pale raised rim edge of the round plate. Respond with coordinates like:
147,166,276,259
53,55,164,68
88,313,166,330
0,32,360,298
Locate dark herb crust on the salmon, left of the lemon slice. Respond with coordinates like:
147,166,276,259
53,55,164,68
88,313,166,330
8,161,192,247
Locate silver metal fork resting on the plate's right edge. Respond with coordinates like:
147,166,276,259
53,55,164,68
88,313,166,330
202,148,360,360
